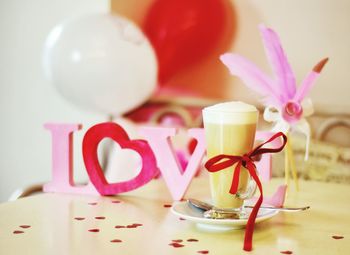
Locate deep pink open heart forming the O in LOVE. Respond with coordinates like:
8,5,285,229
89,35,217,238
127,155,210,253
83,122,158,195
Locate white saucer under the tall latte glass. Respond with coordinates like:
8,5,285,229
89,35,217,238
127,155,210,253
171,201,278,232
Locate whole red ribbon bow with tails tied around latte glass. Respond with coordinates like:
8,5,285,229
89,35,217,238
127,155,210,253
205,132,287,251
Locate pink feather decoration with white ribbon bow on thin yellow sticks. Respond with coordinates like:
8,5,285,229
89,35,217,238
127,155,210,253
220,25,328,186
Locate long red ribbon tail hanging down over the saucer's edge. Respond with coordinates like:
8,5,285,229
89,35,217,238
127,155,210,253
243,162,263,251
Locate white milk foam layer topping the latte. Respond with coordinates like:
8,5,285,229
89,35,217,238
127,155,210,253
203,101,258,124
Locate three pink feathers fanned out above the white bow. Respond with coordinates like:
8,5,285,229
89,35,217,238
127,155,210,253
220,25,328,111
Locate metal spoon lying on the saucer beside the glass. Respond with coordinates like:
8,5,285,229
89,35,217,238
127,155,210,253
187,198,310,213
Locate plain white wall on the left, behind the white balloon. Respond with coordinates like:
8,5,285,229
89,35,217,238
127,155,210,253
0,0,109,201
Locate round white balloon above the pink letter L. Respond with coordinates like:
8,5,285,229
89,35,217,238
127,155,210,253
44,14,158,115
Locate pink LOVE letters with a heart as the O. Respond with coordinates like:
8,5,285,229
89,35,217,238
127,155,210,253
44,122,286,206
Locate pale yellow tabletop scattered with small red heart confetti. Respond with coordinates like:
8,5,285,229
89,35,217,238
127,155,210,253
0,176,350,255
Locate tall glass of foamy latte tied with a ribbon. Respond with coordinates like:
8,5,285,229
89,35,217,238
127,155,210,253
203,101,259,209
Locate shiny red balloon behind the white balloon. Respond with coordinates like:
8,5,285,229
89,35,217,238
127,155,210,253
143,0,229,85
